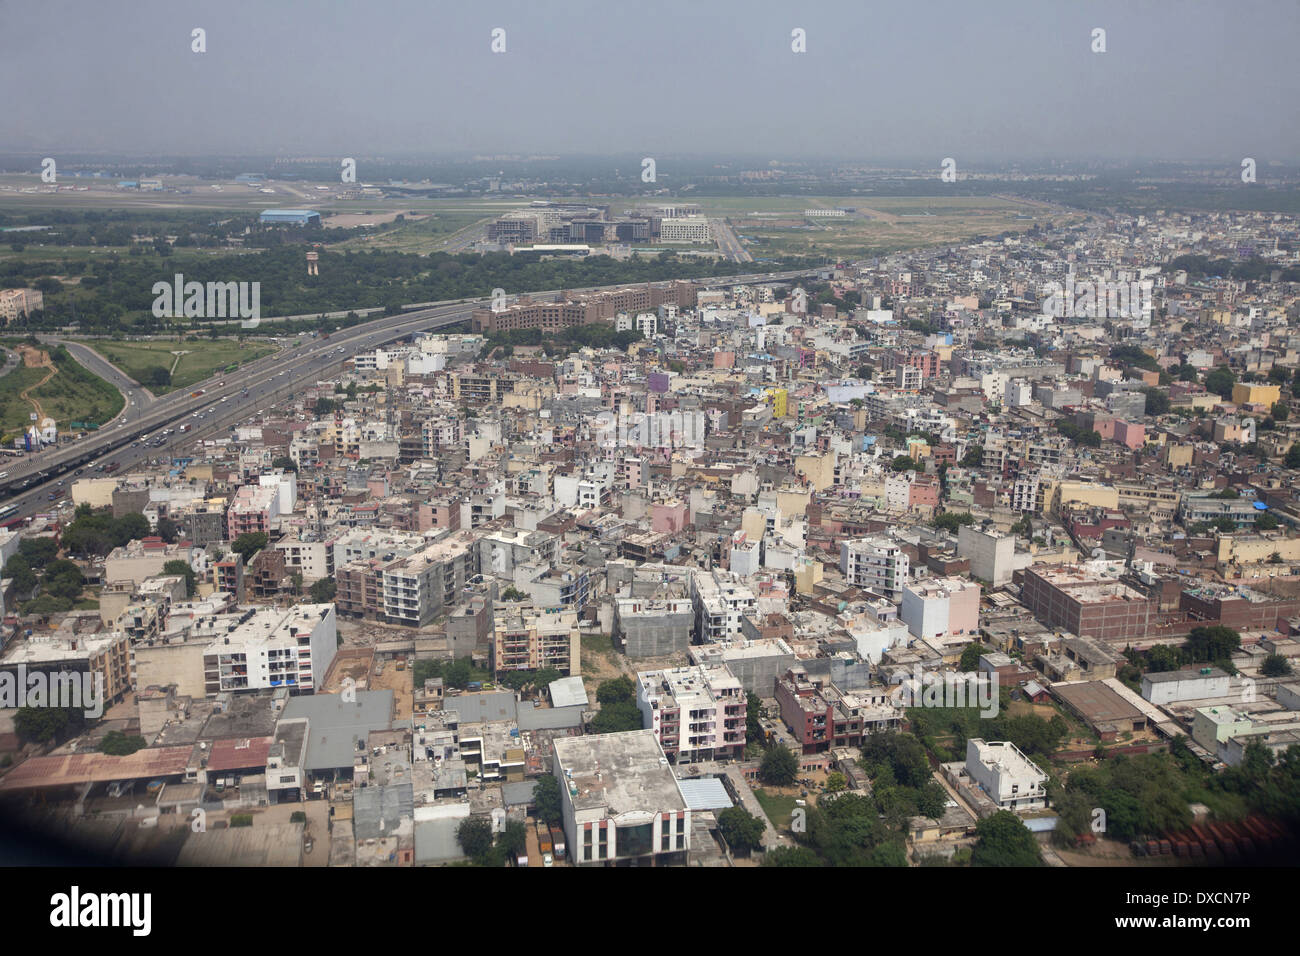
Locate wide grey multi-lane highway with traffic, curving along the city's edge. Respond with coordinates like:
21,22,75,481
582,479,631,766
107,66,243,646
0,269,822,516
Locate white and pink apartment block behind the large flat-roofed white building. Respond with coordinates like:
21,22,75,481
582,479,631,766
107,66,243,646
637,663,746,762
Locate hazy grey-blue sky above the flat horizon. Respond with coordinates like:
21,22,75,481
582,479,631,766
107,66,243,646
0,0,1300,165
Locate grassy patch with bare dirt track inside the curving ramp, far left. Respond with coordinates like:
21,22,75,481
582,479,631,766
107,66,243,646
0,345,126,437
